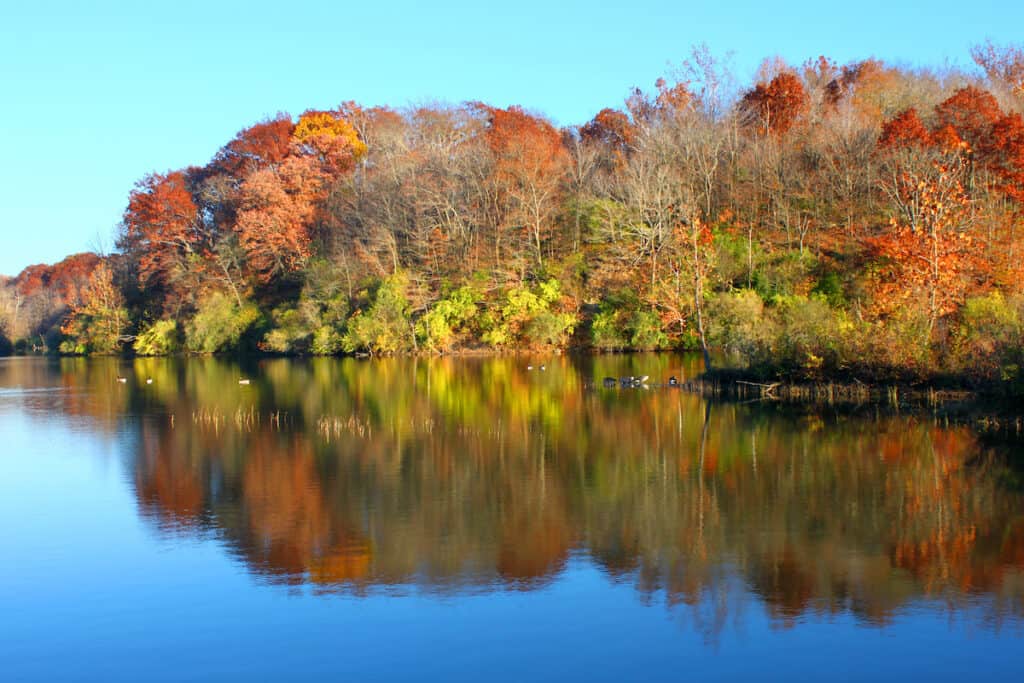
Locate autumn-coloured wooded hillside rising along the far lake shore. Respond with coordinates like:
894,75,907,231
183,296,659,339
0,43,1024,393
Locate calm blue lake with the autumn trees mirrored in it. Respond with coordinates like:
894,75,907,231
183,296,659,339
0,355,1024,681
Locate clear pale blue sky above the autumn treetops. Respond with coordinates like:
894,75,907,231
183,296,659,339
0,0,1024,274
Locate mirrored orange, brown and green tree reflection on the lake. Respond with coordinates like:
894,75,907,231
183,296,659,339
0,355,1024,633
